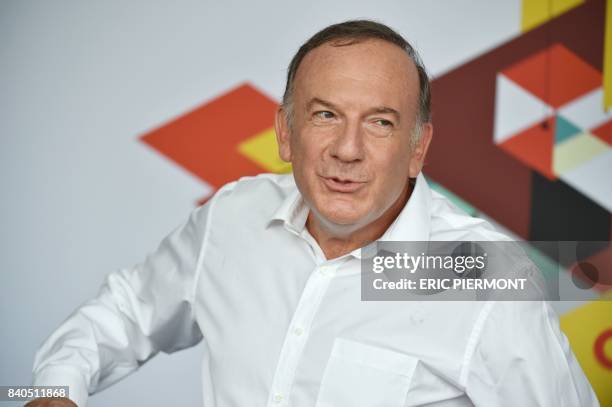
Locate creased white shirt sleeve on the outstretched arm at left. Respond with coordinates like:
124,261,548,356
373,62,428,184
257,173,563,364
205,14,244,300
33,200,212,407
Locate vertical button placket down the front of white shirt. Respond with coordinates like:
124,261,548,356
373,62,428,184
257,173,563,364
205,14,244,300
268,266,335,406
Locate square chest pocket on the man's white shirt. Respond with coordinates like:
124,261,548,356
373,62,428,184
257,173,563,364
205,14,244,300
316,338,418,407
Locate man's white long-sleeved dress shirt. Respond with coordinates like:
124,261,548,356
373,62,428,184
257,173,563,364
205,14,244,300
34,174,599,407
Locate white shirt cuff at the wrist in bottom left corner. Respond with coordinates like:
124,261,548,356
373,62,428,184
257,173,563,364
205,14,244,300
32,366,89,407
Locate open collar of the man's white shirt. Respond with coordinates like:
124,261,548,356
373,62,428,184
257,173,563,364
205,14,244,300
270,173,431,259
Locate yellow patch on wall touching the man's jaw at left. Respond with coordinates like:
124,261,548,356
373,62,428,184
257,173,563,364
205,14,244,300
238,127,291,174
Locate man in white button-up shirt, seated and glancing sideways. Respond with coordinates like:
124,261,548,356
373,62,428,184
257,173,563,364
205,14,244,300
31,21,598,407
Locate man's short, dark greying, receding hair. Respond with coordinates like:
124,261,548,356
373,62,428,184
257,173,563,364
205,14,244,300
282,20,431,144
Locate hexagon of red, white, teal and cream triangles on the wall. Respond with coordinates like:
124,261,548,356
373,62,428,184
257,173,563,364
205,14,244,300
493,44,612,211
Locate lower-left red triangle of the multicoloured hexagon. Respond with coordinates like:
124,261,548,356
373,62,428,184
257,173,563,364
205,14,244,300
500,117,557,181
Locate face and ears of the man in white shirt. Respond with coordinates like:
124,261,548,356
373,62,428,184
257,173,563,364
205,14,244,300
276,40,431,234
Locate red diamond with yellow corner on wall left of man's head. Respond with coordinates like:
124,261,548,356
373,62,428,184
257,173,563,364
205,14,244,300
141,84,291,200
